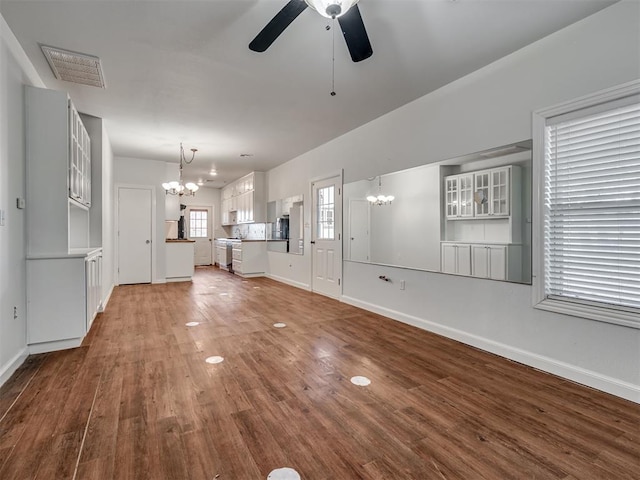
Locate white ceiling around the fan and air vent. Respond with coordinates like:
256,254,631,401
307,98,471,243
0,0,615,187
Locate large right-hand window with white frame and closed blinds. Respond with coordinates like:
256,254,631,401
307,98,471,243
534,82,640,328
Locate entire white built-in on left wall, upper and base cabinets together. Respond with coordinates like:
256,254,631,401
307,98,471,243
25,87,102,353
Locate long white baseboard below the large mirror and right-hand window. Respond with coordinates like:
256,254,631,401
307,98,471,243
341,296,640,403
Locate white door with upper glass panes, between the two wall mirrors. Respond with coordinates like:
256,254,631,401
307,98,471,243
311,176,342,298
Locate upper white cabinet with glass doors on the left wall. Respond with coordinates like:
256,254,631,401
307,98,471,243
25,87,93,255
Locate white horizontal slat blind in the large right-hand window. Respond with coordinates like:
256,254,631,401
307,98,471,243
544,103,640,311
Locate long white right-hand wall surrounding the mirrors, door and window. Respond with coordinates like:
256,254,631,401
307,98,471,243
268,1,640,402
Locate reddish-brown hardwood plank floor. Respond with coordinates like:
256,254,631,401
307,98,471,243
0,268,640,480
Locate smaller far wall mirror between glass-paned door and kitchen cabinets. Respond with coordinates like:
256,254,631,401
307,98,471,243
267,195,304,255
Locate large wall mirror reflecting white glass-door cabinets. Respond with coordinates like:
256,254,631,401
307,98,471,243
343,141,531,283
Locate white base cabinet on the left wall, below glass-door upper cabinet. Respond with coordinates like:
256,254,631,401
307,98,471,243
27,249,102,353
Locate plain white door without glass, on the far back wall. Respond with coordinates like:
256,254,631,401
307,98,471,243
117,187,153,285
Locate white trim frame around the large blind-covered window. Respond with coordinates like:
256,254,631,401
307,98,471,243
531,80,640,330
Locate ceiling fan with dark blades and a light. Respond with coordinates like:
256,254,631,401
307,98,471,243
249,0,373,62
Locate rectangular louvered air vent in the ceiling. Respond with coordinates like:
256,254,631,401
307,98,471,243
40,45,106,88
